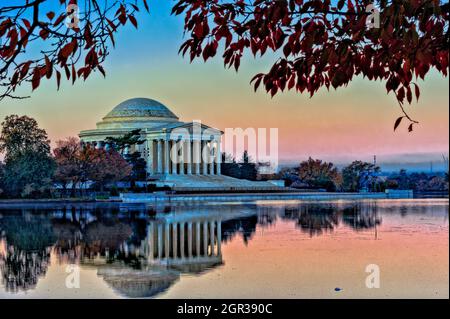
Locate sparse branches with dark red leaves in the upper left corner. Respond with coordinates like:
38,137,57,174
0,0,148,100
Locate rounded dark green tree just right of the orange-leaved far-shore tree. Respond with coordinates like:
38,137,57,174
342,161,380,192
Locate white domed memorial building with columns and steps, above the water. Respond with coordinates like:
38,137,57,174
79,98,275,189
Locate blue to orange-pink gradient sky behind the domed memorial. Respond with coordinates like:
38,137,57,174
0,0,449,170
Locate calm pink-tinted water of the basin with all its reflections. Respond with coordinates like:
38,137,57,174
0,200,449,298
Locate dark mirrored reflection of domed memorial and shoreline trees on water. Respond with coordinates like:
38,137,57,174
0,202,381,297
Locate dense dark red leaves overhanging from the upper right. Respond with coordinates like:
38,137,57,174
172,0,449,131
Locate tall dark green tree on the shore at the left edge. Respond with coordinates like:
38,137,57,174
0,115,56,197
